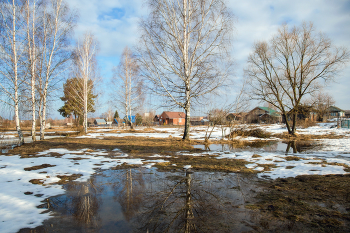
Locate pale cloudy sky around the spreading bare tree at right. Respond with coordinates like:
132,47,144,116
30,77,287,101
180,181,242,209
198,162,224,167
228,0,350,109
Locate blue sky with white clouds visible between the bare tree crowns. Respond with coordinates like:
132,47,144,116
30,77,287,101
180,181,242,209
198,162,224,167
51,0,350,117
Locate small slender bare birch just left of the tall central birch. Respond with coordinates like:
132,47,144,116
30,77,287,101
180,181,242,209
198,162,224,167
113,47,145,126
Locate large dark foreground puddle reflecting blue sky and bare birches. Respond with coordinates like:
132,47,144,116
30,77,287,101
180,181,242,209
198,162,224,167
20,168,259,232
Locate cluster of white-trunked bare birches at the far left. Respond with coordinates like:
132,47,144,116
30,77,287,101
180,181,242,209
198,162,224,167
0,0,76,143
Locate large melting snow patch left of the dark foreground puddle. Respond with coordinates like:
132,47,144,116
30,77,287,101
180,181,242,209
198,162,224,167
0,148,167,233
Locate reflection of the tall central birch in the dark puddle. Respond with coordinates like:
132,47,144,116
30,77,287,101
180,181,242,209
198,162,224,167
134,172,232,233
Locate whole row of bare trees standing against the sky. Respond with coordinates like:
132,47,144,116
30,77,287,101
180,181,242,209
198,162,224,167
0,0,349,142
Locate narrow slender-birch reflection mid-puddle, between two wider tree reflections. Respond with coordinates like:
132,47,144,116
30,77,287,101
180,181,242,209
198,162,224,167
111,169,145,222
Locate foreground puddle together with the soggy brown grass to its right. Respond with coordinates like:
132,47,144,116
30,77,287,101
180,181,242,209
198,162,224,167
19,168,350,233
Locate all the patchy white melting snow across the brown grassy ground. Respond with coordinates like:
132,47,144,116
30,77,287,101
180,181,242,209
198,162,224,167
0,124,350,232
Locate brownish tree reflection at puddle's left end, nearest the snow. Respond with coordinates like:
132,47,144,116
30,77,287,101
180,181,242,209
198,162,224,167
48,178,102,231
